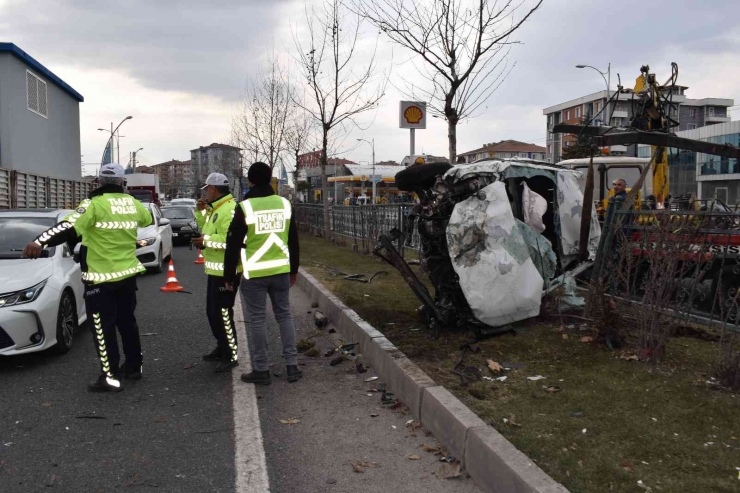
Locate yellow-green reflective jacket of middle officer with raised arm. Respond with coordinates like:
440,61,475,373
195,194,241,277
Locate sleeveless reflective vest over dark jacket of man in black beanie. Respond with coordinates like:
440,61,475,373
241,195,291,279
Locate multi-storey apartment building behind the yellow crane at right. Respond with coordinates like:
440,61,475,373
542,86,735,163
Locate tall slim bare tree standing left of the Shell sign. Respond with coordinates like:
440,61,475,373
293,0,386,238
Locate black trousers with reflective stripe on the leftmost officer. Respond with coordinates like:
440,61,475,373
85,276,143,378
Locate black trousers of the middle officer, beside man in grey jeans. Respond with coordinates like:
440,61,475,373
206,276,241,361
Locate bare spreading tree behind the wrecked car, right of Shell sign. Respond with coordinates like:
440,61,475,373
355,0,543,163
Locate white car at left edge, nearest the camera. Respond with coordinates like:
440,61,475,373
0,209,87,356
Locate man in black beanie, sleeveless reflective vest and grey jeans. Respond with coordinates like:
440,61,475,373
224,162,303,385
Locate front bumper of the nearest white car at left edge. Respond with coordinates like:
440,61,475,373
0,285,59,356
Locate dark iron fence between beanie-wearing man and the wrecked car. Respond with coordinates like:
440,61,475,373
295,204,419,252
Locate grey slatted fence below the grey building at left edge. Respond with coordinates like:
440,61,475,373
0,169,94,209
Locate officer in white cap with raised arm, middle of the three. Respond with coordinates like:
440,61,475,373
193,173,241,373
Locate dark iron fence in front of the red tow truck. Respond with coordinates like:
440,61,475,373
592,197,740,332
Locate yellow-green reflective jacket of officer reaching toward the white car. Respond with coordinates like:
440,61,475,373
63,193,152,284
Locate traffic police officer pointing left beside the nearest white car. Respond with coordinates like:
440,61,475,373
23,163,152,392
